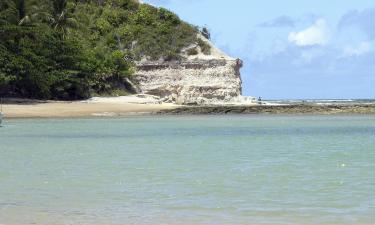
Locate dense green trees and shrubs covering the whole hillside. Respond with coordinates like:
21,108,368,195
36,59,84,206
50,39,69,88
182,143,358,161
0,0,198,99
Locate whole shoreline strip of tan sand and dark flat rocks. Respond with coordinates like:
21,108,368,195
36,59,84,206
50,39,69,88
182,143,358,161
3,96,375,119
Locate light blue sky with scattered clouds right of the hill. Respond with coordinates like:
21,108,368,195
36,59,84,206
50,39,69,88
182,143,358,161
143,0,375,99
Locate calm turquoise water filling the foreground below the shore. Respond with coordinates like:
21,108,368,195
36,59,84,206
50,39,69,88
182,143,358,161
0,116,375,225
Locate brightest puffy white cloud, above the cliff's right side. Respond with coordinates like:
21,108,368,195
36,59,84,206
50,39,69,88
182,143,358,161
288,19,329,46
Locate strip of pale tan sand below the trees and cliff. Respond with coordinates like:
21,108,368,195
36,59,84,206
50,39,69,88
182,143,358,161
3,98,177,118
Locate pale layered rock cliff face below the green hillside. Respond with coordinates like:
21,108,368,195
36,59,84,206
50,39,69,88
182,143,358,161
135,36,251,105
